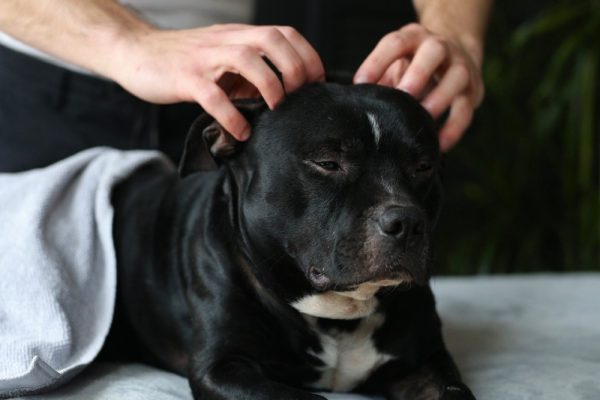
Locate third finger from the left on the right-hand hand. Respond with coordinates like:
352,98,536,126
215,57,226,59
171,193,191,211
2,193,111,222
422,64,469,118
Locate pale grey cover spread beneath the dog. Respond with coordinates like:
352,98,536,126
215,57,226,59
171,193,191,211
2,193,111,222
14,274,600,400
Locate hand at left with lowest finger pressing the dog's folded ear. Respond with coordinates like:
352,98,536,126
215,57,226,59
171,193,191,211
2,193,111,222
108,24,325,140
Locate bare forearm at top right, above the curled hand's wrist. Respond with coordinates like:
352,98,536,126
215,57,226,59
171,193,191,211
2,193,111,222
413,0,493,66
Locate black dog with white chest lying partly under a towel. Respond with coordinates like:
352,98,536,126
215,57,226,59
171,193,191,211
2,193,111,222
107,84,474,400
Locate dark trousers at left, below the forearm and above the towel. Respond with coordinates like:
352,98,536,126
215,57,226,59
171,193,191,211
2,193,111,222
0,46,201,172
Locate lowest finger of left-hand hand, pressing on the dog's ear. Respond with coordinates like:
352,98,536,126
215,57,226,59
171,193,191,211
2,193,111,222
193,80,250,141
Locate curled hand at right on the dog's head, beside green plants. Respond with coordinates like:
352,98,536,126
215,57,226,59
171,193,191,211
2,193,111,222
354,24,484,151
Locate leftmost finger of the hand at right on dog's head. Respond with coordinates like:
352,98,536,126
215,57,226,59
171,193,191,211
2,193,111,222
354,27,426,83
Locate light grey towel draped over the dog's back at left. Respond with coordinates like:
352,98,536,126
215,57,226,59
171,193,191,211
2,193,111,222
0,148,172,397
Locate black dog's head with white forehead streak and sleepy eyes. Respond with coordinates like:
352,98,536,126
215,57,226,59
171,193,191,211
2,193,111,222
181,84,440,304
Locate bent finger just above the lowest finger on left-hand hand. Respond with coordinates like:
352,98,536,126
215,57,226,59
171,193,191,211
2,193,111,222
220,46,285,109
